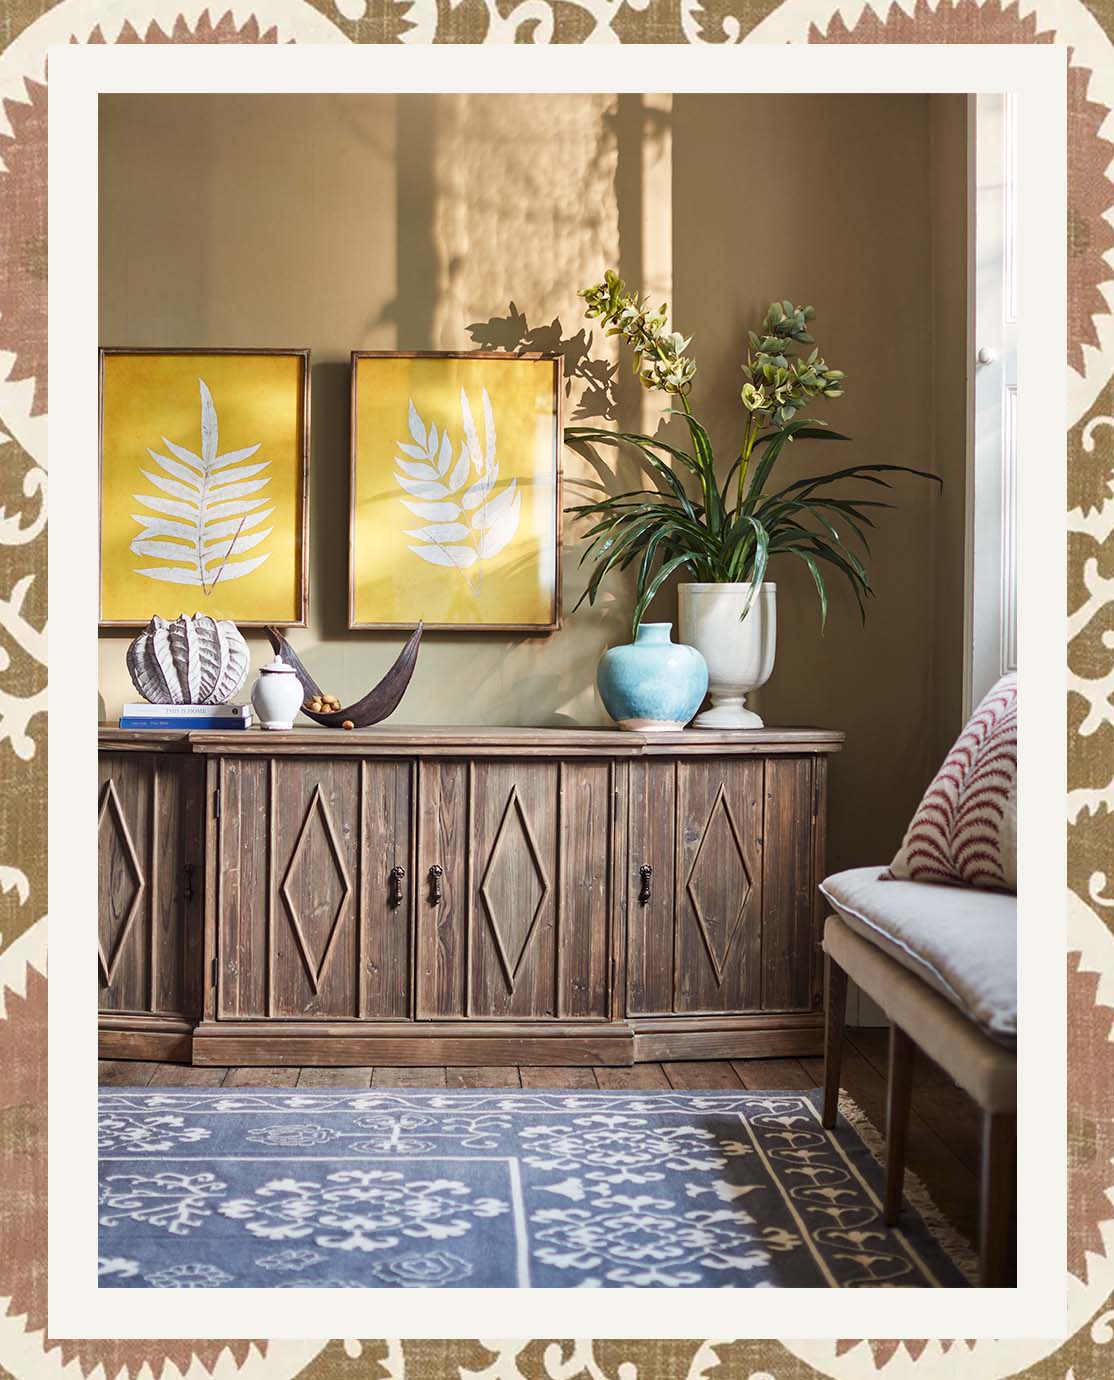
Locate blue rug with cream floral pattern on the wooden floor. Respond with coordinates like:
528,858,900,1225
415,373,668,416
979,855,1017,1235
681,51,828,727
99,1089,968,1289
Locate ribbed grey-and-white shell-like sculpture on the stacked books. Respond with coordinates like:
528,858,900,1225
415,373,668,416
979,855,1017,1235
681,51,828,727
127,613,251,704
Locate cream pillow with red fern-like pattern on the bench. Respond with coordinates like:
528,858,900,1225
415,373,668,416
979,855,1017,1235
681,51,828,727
889,672,1017,891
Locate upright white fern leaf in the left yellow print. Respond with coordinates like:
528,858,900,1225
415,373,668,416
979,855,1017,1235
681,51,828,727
131,378,274,595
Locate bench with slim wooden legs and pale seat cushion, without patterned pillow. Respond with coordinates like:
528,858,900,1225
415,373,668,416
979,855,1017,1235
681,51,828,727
820,867,1017,1286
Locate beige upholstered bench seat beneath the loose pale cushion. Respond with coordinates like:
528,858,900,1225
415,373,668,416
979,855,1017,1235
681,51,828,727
824,915,1017,1112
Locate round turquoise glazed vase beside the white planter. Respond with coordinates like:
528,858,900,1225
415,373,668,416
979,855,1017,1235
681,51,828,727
596,622,708,733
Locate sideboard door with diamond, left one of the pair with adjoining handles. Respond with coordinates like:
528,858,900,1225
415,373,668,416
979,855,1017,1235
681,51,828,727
217,758,410,1020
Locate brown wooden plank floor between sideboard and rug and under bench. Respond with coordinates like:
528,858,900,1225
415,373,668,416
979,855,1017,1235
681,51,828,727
99,1028,979,1241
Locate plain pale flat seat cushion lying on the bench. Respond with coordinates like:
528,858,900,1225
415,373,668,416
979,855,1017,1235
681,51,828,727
820,867,1017,1045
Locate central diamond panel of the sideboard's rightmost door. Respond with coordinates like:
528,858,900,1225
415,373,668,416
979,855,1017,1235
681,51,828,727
674,758,765,1013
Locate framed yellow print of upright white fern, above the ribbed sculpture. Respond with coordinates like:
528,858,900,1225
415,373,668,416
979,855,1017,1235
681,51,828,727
101,349,309,627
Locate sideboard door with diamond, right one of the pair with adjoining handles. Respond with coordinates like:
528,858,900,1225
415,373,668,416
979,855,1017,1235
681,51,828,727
417,760,614,1020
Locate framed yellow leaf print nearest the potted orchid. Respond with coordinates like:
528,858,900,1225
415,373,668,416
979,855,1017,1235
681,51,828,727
348,351,563,633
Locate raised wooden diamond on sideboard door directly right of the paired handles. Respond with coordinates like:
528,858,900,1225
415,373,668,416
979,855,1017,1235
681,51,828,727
479,787,549,991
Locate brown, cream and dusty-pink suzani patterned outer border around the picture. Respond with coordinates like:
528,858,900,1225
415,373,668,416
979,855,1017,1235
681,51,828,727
0,0,1114,1380
